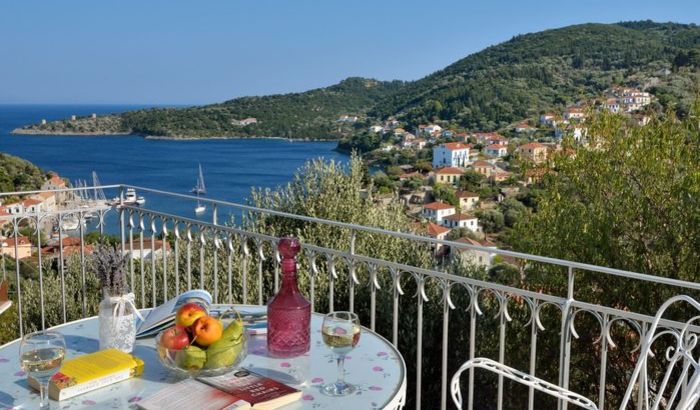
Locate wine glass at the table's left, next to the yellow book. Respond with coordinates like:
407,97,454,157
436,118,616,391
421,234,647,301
19,331,66,410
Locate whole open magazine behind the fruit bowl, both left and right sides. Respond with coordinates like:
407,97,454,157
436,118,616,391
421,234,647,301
136,289,267,338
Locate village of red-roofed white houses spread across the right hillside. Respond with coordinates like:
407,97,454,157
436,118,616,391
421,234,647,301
356,87,654,268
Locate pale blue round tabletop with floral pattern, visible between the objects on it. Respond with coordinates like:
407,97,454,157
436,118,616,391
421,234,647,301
0,306,406,410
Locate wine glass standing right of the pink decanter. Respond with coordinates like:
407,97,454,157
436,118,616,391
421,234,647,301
321,312,360,396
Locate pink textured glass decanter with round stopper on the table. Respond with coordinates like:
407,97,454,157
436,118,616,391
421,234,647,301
267,236,311,357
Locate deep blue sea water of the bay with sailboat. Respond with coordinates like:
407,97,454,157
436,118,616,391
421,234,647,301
0,105,348,232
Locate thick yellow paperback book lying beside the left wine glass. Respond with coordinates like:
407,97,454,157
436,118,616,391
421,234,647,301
29,349,143,400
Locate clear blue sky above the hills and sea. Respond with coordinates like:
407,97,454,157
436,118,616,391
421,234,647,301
0,0,700,104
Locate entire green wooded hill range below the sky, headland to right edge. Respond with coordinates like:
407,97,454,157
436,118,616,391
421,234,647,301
13,21,700,152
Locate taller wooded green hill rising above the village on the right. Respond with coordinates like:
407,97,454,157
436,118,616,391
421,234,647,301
370,22,700,130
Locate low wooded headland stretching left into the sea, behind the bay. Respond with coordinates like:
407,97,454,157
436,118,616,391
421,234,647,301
14,78,404,139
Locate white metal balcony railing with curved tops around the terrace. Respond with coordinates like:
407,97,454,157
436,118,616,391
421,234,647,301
0,185,700,409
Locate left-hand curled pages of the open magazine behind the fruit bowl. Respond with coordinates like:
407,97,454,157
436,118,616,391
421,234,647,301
136,289,212,338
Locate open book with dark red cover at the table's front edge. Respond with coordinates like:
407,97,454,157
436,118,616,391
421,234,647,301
138,369,301,410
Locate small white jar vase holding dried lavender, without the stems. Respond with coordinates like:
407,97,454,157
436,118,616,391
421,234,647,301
98,293,136,353
